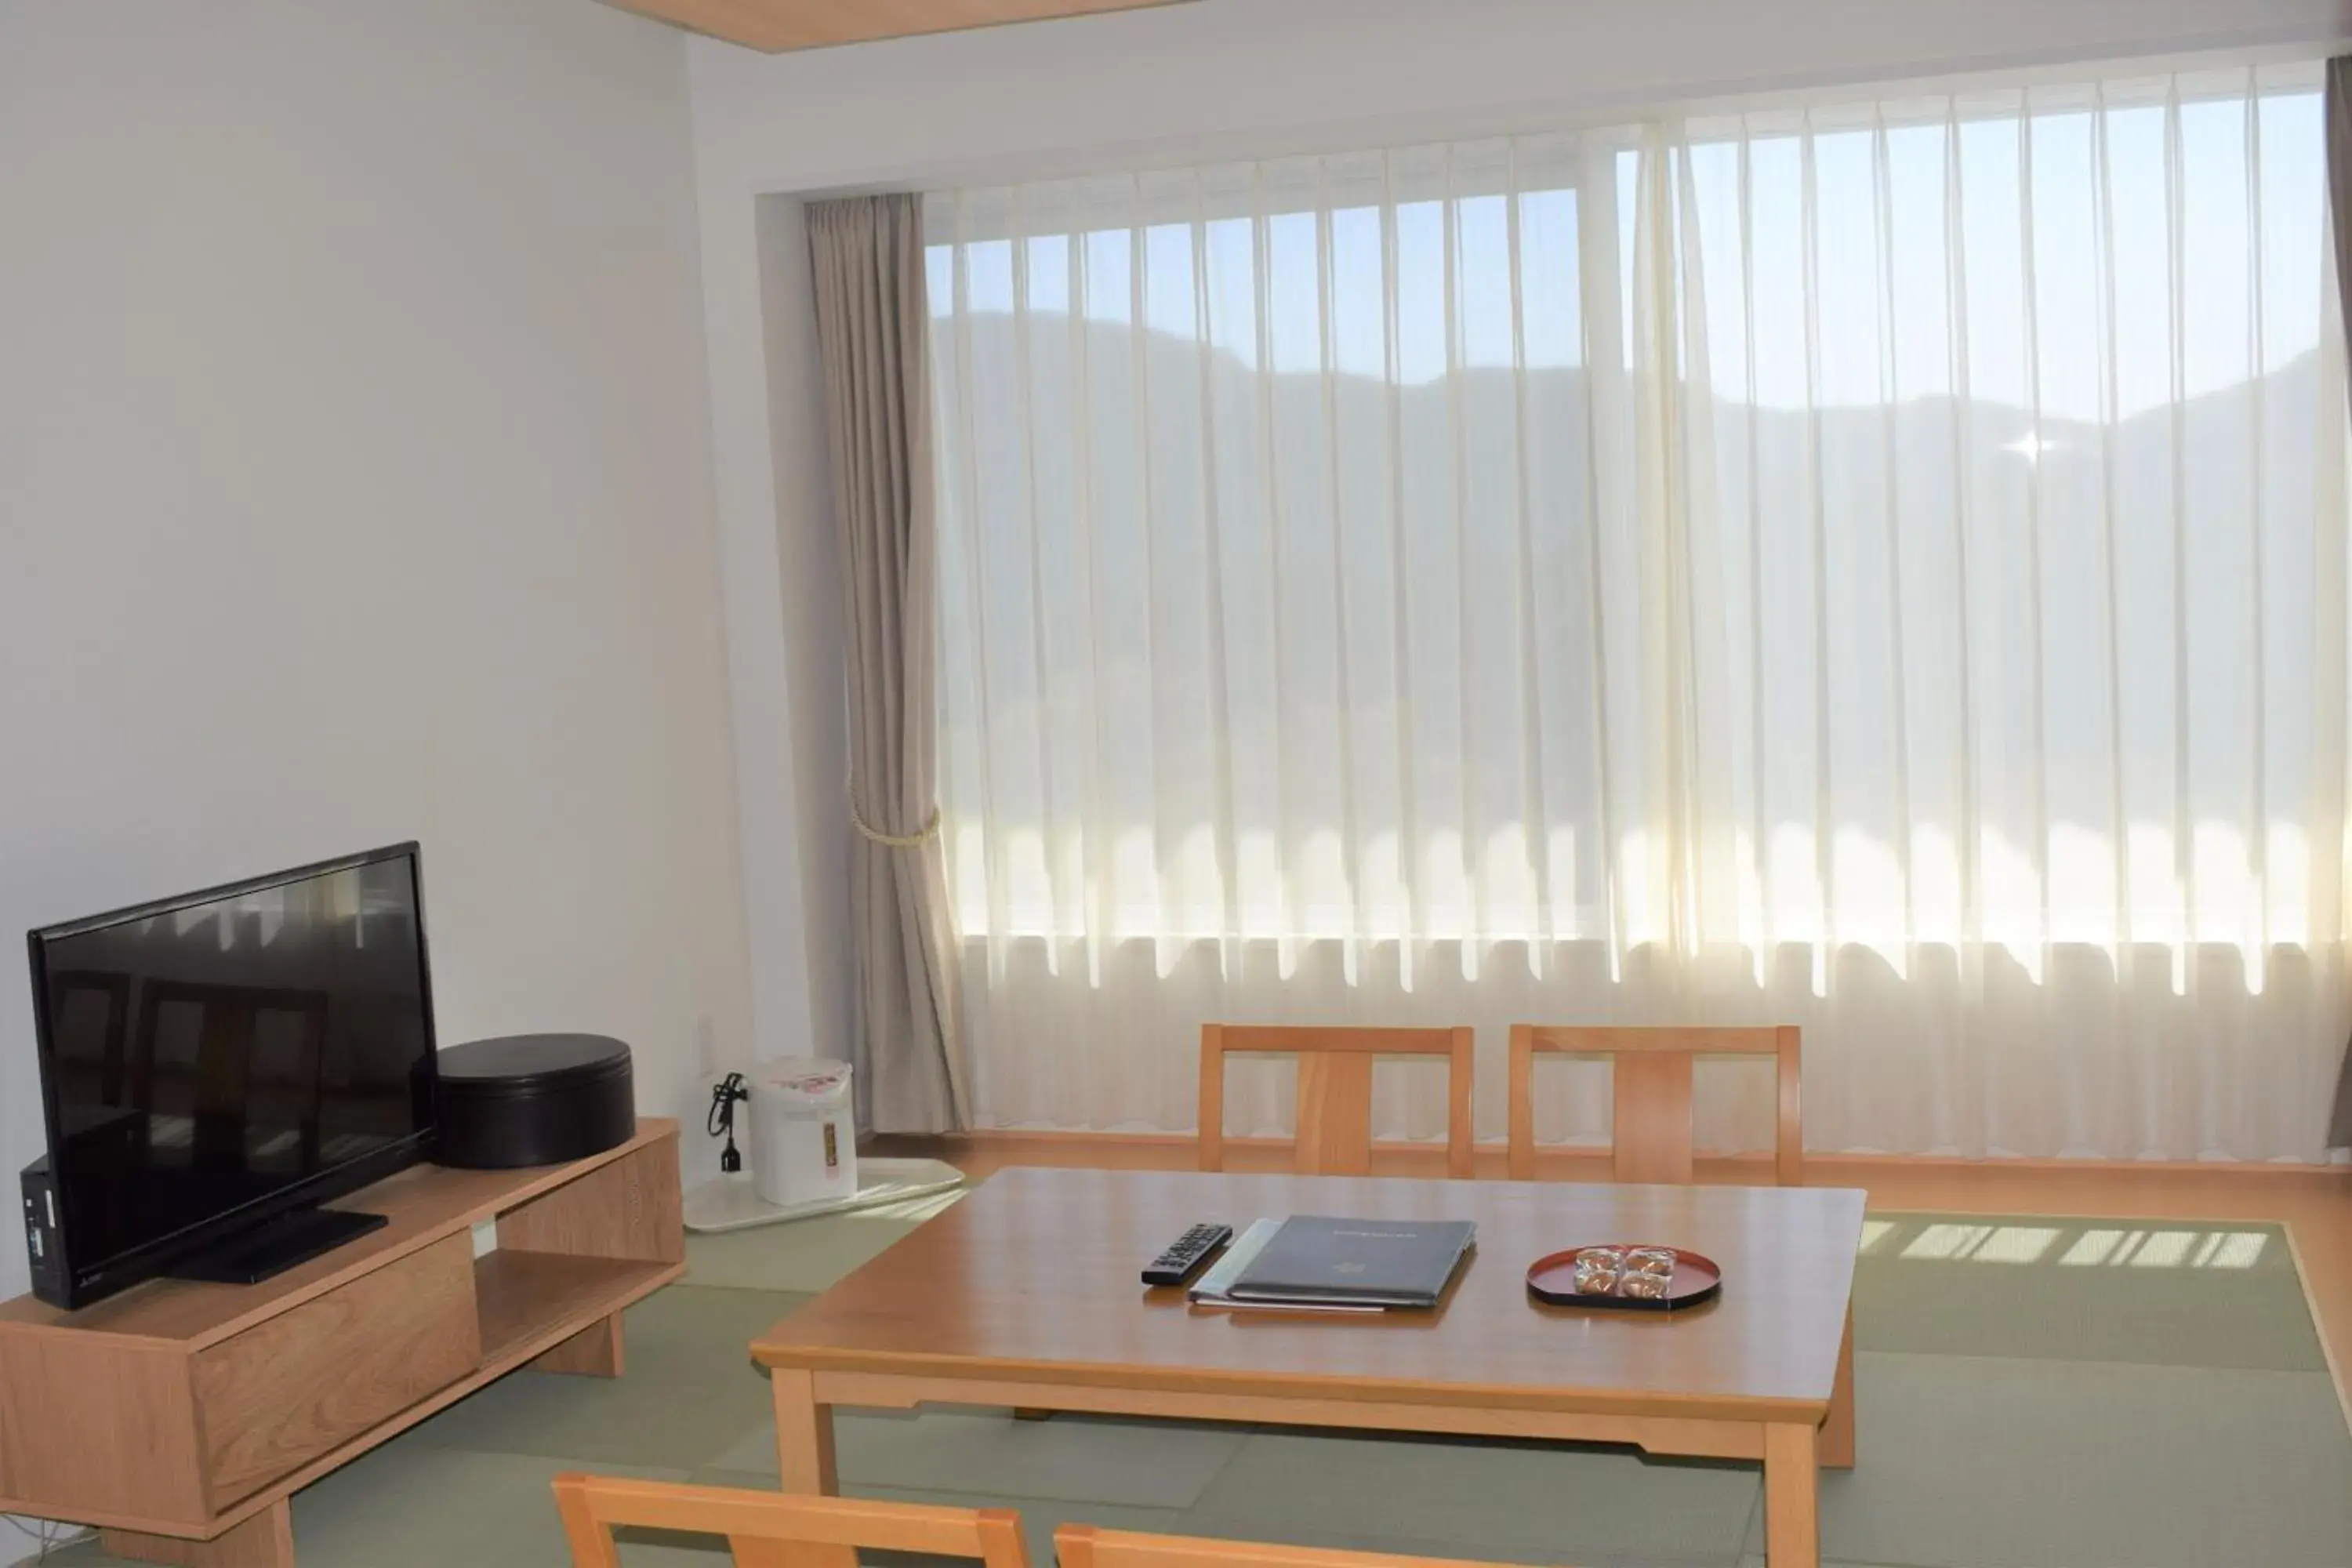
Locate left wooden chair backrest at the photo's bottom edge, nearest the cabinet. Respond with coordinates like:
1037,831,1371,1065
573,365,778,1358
555,1474,1028,1568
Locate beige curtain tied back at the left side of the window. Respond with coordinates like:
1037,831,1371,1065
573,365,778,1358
809,195,971,1133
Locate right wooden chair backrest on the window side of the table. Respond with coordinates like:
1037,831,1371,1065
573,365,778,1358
1510,1022,1804,1187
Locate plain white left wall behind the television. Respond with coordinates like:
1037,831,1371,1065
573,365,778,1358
0,0,748,1293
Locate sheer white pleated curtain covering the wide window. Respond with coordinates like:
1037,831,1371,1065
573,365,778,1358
927,66,2347,1159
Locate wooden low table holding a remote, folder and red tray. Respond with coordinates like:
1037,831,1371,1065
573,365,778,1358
750,1168,1863,1568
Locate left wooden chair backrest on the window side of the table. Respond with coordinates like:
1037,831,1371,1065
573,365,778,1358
1200,1022,1477,1175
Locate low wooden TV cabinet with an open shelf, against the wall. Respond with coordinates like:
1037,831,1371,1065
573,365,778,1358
0,1116,687,1568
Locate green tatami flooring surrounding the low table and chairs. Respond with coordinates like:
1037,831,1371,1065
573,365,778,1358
18,1213,2352,1568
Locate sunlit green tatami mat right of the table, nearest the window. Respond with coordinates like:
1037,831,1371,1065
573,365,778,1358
1853,1213,2326,1373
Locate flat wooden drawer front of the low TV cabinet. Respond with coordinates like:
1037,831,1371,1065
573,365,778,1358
191,1232,482,1509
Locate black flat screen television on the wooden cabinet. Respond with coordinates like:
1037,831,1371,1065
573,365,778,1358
26,844,435,1307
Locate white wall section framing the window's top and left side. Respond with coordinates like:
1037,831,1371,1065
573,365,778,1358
687,0,2352,1109
